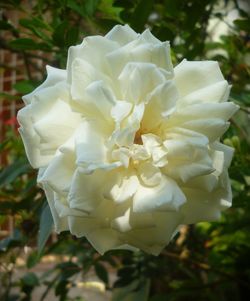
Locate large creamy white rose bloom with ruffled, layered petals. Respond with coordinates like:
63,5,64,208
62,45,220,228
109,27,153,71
18,25,238,255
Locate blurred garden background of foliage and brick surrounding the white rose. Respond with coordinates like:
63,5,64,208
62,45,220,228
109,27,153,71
0,0,250,301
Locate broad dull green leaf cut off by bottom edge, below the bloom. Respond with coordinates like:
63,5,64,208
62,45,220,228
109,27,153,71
111,279,150,301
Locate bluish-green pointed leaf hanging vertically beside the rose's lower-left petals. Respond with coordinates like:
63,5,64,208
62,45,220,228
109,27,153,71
38,204,53,253
